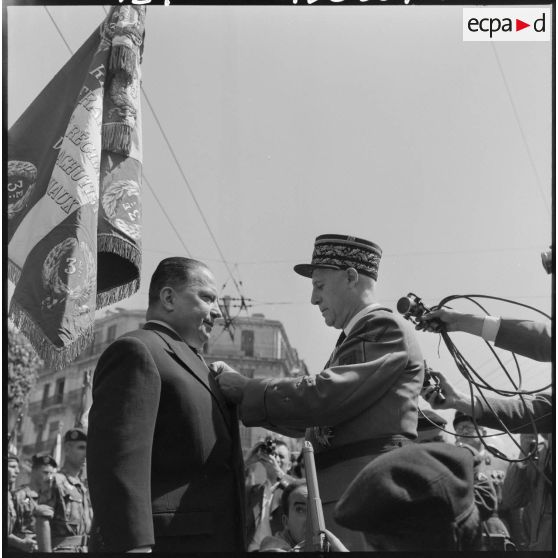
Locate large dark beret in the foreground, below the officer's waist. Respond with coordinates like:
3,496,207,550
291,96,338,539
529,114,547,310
334,442,475,533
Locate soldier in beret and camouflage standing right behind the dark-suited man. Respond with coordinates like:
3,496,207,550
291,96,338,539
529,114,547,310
35,428,93,552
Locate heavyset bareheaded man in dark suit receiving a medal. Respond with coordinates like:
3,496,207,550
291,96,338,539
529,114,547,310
87,257,245,553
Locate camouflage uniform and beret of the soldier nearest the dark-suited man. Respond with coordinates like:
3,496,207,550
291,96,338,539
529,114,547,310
35,429,93,552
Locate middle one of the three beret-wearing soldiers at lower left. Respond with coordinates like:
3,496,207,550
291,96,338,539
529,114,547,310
13,454,58,550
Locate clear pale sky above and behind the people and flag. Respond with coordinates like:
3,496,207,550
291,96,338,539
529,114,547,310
6,4,553,460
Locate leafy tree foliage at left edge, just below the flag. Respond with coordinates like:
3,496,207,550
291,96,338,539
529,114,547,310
8,323,43,411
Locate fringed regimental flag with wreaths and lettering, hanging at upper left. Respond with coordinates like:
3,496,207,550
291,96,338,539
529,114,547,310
7,6,145,368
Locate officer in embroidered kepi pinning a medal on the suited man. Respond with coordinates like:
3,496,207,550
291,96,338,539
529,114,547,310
212,234,424,551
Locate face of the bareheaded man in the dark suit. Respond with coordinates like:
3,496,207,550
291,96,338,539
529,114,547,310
169,267,221,349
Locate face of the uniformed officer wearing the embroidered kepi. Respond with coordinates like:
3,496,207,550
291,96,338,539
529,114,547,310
310,268,350,329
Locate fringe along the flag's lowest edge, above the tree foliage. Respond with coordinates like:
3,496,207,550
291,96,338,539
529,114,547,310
8,298,95,370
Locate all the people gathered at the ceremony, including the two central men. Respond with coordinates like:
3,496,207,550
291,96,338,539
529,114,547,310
8,235,554,553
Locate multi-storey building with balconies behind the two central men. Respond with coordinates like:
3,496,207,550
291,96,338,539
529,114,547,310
17,308,308,464
